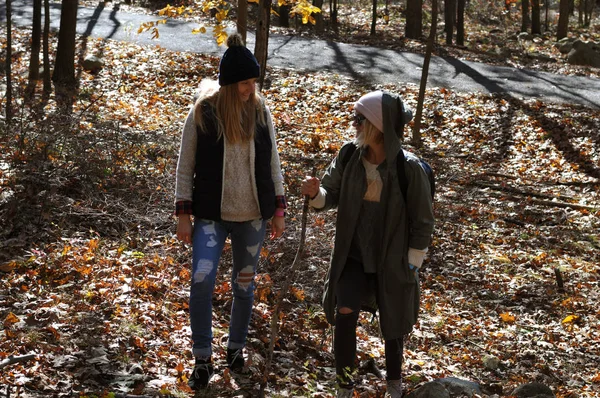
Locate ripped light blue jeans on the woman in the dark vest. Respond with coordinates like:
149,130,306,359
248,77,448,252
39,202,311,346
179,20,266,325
190,219,266,357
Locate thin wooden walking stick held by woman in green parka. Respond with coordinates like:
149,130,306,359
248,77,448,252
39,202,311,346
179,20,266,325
259,167,316,398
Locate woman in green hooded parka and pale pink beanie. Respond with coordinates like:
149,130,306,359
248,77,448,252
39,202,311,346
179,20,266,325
301,91,434,398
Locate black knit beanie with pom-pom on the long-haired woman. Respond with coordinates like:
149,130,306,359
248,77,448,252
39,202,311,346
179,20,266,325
219,33,260,86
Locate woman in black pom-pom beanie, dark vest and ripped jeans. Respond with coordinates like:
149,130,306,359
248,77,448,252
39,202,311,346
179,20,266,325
175,34,286,390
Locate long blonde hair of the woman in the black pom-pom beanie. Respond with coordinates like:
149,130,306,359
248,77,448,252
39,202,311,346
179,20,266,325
194,80,266,143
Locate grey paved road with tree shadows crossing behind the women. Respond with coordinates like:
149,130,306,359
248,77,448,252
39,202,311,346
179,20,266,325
0,0,600,108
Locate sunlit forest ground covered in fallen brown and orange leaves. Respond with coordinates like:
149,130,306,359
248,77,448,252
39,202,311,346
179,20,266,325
0,15,600,397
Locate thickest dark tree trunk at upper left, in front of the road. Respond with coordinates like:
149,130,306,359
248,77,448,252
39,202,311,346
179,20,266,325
52,0,77,110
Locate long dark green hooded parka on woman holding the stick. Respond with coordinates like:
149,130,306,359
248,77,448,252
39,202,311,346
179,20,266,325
317,93,434,340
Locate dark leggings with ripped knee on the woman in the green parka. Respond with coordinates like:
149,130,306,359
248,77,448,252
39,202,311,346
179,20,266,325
333,259,404,386
